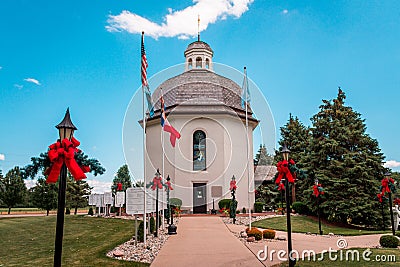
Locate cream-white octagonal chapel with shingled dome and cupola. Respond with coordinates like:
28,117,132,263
146,38,258,213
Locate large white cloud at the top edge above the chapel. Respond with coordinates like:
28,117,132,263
106,0,254,39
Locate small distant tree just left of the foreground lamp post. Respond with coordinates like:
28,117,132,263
30,178,58,216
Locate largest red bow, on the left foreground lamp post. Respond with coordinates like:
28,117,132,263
45,137,90,183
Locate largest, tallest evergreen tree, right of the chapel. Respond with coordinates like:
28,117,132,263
300,88,384,226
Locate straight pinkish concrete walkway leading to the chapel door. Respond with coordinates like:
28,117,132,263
151,216,264,267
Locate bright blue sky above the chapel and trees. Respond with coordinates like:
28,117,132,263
0,0,400,193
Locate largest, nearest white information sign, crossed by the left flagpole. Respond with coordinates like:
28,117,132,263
126,187,156,215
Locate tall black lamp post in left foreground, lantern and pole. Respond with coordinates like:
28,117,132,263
54,108,77,267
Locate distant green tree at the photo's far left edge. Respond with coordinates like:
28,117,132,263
0,167,27,214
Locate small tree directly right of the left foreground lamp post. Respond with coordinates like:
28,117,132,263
65,173,93,215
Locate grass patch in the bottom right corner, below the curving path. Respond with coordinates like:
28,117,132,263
279,248,400,267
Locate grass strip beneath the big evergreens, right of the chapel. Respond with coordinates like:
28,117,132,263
252,216,391,236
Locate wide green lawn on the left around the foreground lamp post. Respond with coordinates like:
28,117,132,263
0,215,149,267
